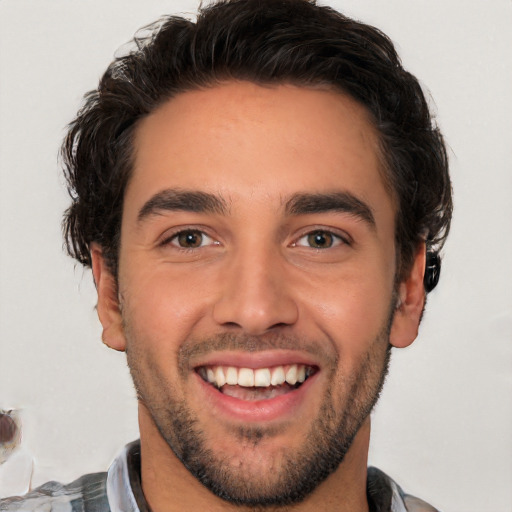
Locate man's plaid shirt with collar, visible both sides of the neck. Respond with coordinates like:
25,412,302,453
0,441,438,512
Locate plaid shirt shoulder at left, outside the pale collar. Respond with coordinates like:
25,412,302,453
0,473,110,512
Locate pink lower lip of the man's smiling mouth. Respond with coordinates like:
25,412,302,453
194,368,319,424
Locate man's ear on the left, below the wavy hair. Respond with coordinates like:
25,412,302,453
91,243,126,351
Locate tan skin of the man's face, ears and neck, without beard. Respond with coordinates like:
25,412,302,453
92,82,425,512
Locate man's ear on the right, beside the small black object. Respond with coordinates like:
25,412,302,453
390,242,426,348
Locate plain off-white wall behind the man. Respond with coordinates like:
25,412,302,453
0,0,512,512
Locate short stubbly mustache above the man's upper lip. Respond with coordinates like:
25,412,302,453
178,333,338,375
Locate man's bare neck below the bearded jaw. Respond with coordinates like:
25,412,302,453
139,403,370,512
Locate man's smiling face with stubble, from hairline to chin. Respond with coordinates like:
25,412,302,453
94,82,422,504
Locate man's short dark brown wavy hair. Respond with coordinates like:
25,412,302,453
62,0,452,286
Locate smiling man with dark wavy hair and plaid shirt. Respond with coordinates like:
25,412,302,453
0,0,452,512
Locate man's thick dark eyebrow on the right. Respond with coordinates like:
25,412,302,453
285,192,376,229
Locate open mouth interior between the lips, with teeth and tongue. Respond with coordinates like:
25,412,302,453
196,364,318,400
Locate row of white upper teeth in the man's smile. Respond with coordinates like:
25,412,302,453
199,364,311,388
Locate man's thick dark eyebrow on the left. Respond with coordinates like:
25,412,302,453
137,189,227,222
